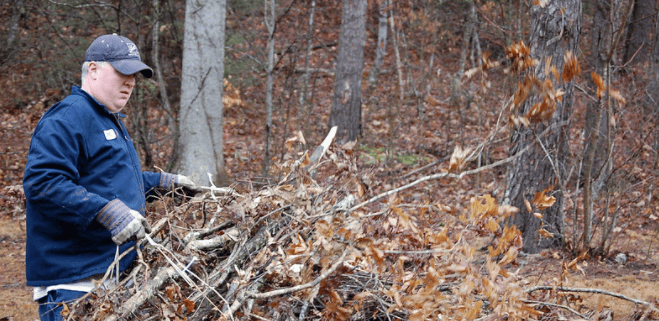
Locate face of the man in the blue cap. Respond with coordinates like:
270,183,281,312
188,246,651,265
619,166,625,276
90,63,135,113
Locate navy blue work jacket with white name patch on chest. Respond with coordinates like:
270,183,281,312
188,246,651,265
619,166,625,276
23,86,174,286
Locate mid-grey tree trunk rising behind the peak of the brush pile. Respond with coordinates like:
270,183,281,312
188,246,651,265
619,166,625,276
329,0,367,143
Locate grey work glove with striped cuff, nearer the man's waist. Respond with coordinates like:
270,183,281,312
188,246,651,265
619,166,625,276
96,200,151,245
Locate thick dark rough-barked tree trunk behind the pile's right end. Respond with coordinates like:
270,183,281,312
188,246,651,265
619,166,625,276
504,0,581,253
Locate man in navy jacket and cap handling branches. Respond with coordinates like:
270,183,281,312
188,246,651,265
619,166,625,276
23,34,193,320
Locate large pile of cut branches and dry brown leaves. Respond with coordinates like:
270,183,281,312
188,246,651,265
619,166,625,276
64,147,636,320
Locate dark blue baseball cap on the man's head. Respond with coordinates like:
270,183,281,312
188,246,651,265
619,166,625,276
85,34,153,78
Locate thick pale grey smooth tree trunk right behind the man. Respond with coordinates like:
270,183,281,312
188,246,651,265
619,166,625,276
179,0,229,185
